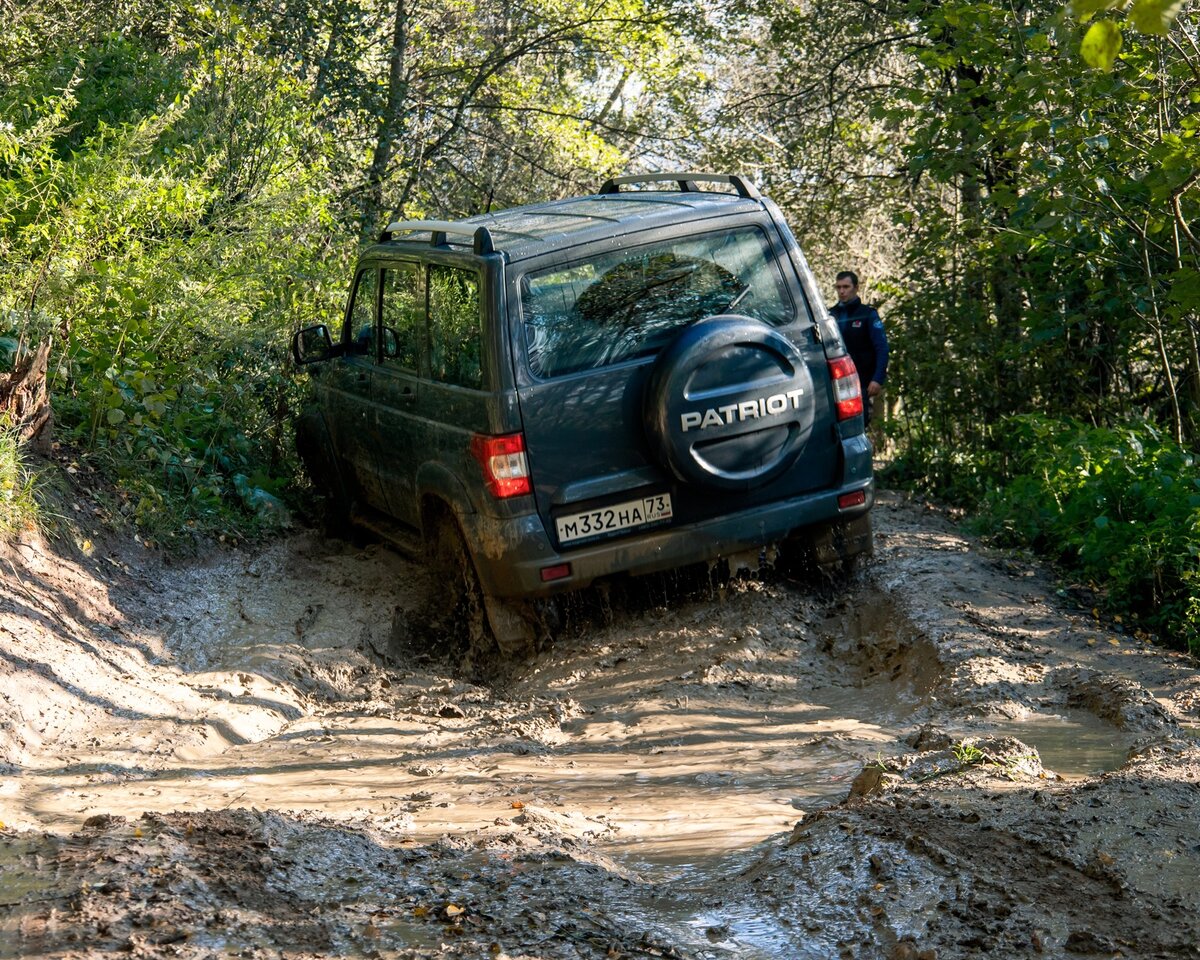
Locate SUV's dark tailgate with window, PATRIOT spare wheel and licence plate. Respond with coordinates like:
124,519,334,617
518,221,838,548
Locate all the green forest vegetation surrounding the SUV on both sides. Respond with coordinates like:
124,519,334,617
0,0,1200,650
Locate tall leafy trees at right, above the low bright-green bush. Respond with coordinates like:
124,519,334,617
883,2,1200,502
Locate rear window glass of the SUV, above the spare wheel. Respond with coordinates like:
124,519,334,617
521,227,794,377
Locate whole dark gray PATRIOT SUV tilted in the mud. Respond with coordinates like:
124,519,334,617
293,173,872,653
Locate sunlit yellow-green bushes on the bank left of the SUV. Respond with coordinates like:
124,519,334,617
0,11,355,538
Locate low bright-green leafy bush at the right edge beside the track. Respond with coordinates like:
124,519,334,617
977,415,1200,653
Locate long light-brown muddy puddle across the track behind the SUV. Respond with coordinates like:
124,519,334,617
11,643,902,860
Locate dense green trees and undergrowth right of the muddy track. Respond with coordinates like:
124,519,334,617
742,0,1200,643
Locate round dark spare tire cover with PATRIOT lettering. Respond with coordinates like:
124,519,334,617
644,314,814,490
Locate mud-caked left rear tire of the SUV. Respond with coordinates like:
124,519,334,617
428,517,538,659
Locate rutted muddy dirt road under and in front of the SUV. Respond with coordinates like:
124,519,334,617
0,494,1200,960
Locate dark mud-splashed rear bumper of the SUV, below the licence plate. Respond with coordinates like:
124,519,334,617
462,476,875,596
